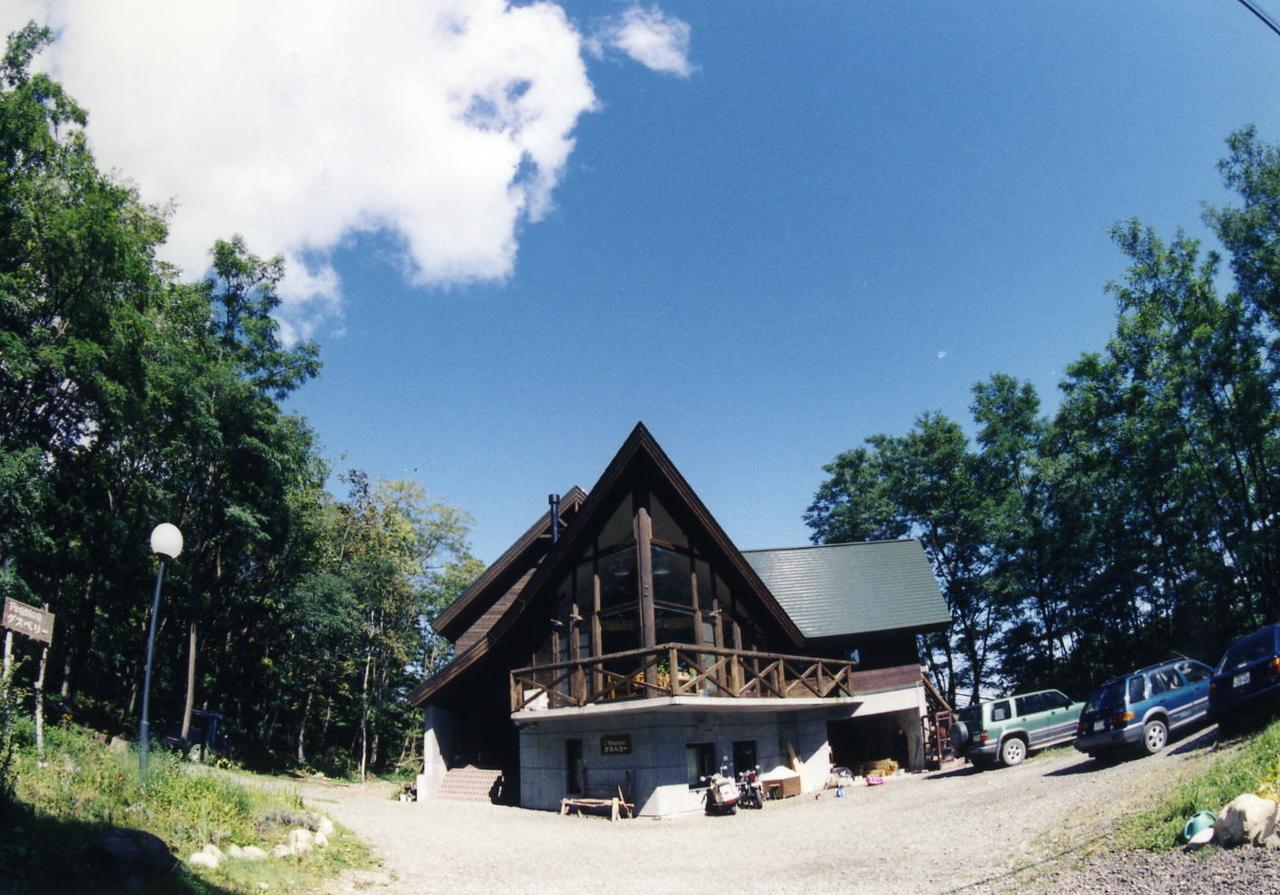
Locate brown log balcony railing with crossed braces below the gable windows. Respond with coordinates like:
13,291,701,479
511,643,854,712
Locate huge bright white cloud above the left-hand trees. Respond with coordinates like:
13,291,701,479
0,0,604,337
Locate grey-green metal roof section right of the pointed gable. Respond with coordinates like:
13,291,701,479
742,540,951,639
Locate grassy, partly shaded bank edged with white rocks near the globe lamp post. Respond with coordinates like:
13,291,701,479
0,726,370,895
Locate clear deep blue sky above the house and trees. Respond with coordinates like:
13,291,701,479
8,0,1280,561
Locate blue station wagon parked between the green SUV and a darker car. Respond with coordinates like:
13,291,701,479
1075,659,1213,758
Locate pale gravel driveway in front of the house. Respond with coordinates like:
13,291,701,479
282,731,1280,895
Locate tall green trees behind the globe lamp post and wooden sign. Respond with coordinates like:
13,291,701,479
0,26,479,771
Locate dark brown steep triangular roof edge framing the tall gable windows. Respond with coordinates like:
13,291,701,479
489,423,804,647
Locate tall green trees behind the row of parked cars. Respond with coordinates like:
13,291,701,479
805,128,1280,698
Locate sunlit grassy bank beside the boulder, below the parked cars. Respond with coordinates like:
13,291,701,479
1116,721,1280,851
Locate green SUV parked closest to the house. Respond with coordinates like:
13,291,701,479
951,690,1084,767
